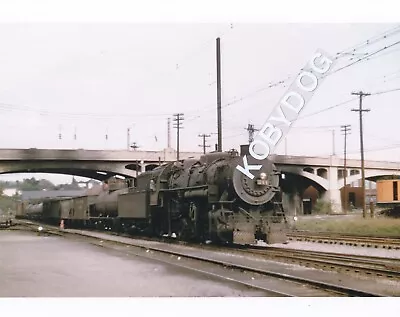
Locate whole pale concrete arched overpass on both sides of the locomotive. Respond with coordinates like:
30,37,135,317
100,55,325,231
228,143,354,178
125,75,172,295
0,148,400,209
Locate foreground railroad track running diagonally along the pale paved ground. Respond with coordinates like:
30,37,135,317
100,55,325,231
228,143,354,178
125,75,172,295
10,220,396,297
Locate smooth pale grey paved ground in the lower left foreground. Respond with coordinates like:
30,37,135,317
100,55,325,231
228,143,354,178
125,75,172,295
0,230,265,297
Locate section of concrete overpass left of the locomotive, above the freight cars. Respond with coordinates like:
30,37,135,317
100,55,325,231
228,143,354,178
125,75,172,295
0,149,201,180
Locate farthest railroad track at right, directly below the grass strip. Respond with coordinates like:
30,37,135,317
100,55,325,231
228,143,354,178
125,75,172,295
288,231,400,250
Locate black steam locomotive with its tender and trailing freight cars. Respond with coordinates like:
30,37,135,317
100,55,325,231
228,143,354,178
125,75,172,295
17,150,288,244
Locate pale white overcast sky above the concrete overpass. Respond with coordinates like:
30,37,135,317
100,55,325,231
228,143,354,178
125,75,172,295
0,23,400,181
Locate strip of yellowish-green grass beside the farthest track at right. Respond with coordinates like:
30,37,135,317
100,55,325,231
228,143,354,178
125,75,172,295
295,215,400,237
